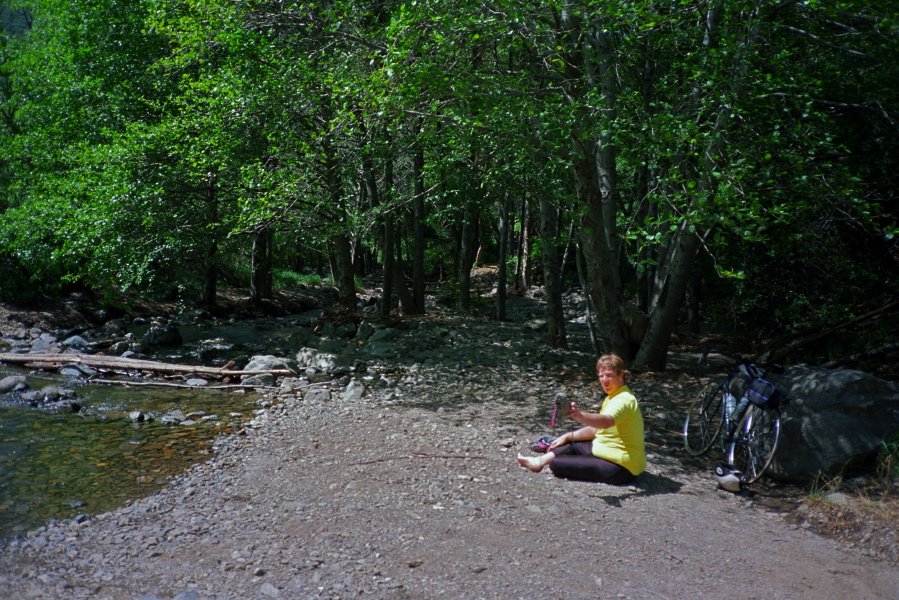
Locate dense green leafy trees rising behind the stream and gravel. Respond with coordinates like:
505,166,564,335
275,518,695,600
0,0,899,367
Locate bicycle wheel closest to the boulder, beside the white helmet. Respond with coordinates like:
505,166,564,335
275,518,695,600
729,406,780,483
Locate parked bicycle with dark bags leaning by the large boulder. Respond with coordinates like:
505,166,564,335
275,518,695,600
683,350,789,483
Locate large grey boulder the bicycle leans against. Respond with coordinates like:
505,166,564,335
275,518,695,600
767,366,899,481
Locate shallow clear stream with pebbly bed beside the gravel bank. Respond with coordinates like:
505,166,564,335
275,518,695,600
0,325,316,539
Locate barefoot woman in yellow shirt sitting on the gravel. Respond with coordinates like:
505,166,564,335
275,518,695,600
518,354,646,485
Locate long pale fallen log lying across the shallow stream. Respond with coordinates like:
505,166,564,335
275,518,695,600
0,352,295,378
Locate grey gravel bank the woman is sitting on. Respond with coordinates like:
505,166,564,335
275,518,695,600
0,312,899,600
